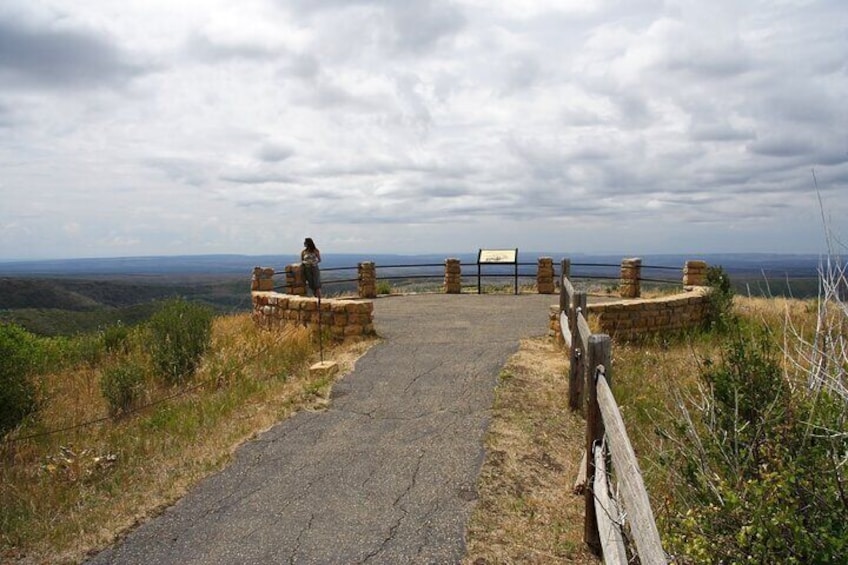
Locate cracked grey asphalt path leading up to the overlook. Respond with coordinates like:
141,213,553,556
91,295,557,564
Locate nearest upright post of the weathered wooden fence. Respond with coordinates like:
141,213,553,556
583,334,612,554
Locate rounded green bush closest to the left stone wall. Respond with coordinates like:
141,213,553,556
148,299,213,384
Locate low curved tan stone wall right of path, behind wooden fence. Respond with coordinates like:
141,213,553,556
550,286,710,343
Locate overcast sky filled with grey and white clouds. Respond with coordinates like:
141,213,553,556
0,0,848,260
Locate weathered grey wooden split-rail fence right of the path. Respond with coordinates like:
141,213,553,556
559,259,668,565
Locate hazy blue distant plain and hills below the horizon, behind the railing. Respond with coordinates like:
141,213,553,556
0,251,836,335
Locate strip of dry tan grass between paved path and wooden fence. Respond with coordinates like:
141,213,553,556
463,338,598,565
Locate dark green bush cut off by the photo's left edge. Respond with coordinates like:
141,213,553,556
0,324,40,436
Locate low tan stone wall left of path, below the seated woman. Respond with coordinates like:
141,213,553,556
251,290,375,342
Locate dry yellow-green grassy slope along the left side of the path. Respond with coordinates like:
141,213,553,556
0,315,373,563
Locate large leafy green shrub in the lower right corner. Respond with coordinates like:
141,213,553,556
665,332,848,563
